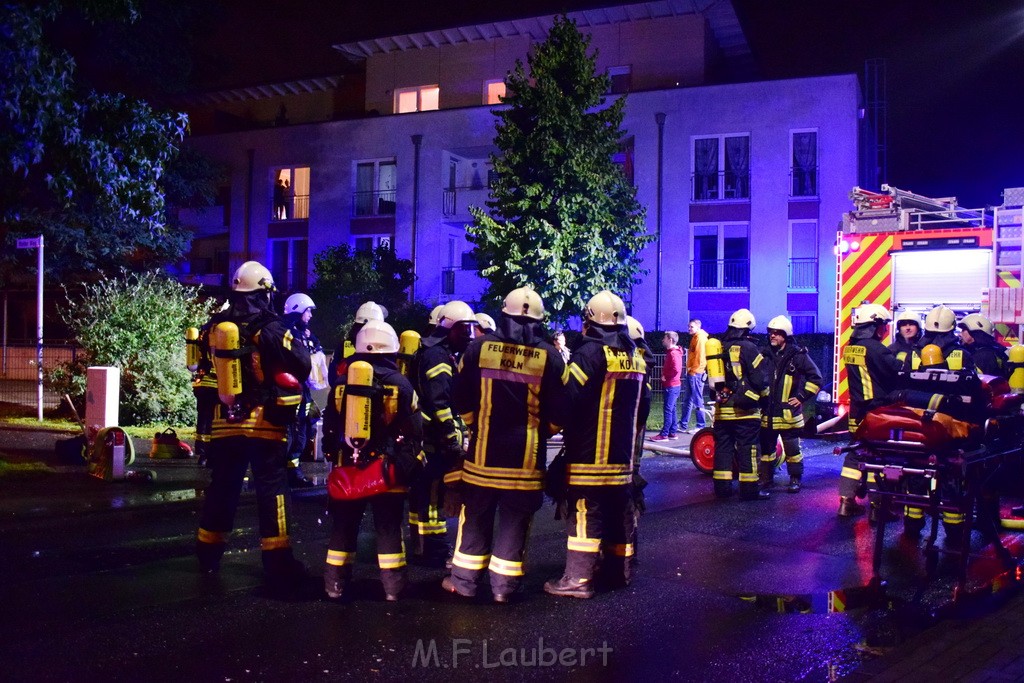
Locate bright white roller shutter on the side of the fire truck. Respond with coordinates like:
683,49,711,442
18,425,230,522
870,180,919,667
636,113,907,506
891,249,992,310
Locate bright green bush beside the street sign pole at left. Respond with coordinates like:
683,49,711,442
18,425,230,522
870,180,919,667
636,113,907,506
47,271,211,425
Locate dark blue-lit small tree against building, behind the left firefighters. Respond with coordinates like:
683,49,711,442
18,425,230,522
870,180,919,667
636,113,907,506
309,245,429,346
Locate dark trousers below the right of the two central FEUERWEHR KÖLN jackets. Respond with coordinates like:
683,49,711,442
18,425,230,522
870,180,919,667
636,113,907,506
565,484,637,585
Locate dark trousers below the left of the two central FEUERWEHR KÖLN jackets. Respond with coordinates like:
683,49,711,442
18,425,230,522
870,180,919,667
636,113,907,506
452,482,544,595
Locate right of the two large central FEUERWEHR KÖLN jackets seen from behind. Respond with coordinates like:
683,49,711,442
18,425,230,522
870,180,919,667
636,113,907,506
563,325,650,486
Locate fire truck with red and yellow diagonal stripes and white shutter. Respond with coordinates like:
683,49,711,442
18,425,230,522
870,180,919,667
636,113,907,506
819,185,1024,431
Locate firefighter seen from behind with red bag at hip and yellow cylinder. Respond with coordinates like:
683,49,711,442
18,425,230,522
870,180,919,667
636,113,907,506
324,319,423,602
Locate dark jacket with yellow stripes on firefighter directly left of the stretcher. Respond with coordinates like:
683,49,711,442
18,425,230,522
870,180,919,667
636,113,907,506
843,326,901,423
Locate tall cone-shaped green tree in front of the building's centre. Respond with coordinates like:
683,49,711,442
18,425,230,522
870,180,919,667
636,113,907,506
468,16,653,322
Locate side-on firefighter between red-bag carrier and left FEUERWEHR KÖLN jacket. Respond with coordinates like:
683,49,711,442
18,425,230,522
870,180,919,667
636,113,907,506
409,301,477,566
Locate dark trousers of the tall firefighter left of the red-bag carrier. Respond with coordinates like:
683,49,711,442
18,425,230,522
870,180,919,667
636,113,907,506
197,436,294,574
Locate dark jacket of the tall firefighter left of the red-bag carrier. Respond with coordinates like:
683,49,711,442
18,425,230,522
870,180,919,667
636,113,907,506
207,293,309,441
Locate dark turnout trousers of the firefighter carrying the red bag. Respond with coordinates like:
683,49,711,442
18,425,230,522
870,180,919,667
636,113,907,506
325,492,406,596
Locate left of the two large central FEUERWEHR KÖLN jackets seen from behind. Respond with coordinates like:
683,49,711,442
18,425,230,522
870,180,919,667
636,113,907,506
453,315,566,490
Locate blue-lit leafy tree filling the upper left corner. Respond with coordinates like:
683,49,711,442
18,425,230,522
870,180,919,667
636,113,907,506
0,0,187,284
